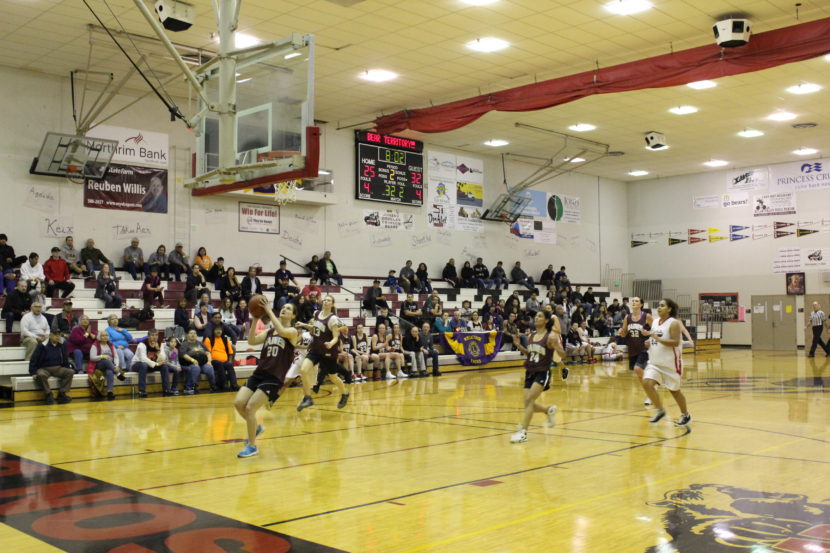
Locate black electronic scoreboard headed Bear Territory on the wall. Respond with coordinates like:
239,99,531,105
355,131,424,205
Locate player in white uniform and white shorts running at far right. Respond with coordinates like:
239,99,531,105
641,298,692,426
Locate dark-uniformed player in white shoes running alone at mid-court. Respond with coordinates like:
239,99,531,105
510,311,565,444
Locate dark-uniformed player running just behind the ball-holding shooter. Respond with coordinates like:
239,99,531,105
297,295,352,411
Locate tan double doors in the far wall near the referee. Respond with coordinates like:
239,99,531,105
752,296,797,351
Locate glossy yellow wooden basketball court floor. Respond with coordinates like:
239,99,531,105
0,349,830,553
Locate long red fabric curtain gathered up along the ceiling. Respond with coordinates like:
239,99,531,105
375,18,830,134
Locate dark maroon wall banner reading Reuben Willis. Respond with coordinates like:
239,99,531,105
84,163,167,213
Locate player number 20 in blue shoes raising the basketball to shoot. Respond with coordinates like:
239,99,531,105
233,301,297,458
